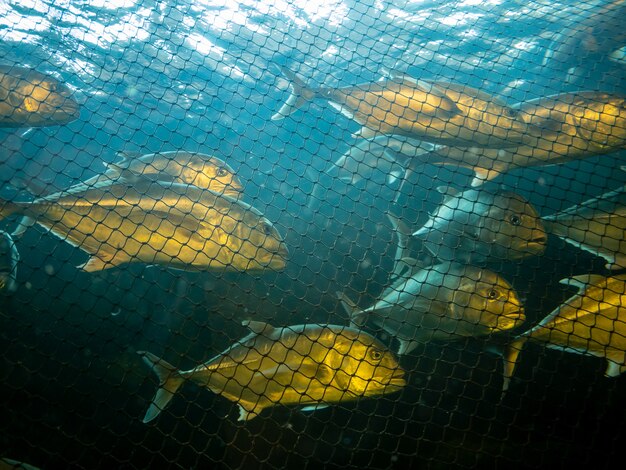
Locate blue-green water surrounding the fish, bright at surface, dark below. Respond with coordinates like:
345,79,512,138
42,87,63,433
0,0,626,468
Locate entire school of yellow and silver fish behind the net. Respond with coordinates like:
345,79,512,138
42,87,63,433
0,1,626,430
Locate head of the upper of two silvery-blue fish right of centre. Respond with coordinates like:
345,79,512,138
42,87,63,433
476,192,547,260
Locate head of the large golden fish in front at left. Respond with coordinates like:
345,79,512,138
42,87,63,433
222,207,289,271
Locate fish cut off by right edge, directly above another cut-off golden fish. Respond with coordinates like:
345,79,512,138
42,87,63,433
542,167,626,269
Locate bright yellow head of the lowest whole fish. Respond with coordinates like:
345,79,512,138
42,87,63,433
324,327,406,397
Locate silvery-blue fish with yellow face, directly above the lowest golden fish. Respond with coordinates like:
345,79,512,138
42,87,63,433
337,263,525,354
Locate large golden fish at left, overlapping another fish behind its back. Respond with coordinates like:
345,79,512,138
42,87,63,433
0,180,288,272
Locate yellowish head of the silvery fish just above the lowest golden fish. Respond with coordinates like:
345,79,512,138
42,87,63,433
450,266,526,336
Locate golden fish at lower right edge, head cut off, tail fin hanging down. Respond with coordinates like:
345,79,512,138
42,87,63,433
503,274,626,391
